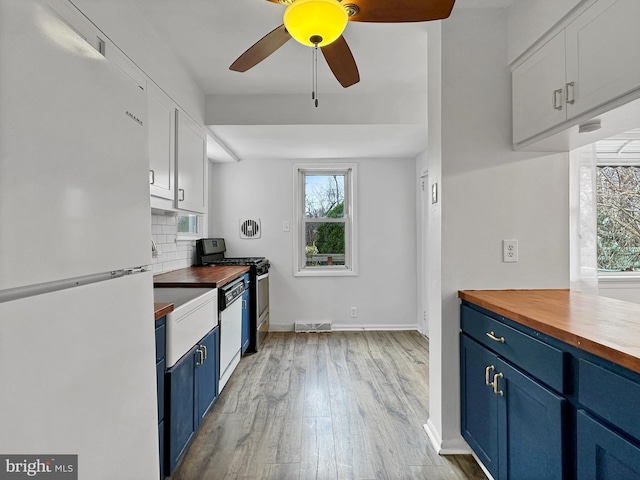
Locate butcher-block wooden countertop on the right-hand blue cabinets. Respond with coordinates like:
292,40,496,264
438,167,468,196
458,290,640,373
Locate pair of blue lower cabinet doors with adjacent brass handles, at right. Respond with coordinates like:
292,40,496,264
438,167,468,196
460,334,566,480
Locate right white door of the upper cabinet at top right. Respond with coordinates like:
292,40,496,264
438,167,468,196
566,0,640,118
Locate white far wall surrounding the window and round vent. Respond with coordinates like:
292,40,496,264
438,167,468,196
209,159,417,330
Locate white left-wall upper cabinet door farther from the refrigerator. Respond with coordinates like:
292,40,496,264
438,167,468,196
176,110,207,213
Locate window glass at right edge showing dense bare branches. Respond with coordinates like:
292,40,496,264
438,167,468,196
596,165,640,272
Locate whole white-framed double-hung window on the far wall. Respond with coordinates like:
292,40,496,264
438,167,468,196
294,164,356,276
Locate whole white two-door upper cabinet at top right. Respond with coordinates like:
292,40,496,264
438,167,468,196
512,0,640,146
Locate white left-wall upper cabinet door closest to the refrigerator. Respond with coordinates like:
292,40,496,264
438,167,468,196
147,82,176,200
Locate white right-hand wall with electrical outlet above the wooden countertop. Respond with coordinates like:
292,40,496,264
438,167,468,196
427,9,569,453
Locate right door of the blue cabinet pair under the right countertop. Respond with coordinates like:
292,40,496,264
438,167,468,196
496,358,566,480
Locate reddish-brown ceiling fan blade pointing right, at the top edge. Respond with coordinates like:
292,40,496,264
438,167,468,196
345,0,455,23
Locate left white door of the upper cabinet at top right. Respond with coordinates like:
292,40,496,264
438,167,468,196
511,32,566,143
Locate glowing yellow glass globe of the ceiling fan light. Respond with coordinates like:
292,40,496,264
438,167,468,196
284,0,349,47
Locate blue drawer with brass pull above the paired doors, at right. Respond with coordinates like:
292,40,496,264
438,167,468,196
460,305,567,393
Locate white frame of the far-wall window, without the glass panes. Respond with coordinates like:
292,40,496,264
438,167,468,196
293,163,358,277
